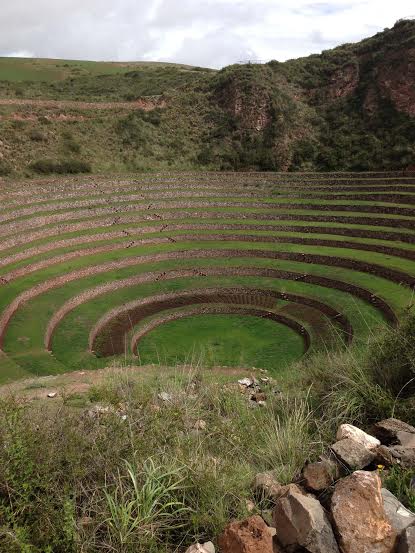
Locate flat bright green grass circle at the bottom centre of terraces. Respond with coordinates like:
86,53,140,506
139,315,304,371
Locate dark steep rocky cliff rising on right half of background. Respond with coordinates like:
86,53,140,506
208,21,415,171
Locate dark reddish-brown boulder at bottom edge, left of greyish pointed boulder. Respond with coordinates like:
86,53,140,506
219,516,273,553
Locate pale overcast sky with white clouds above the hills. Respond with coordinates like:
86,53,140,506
0,0,415,67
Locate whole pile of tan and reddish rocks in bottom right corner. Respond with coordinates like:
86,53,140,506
189,419,415,553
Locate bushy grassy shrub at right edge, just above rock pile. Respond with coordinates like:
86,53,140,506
299,316,415,432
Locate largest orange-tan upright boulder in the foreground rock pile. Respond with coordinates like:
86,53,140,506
331,470,397,553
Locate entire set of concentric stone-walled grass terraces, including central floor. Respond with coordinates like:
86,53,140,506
0,173,415,381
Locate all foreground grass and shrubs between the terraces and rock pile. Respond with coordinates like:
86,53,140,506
0,314,415,553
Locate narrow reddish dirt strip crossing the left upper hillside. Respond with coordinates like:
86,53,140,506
0,96,166,111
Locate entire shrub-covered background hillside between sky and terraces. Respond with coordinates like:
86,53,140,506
0,20,415,177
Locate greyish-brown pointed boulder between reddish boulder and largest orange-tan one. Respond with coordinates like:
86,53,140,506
273,492,339,553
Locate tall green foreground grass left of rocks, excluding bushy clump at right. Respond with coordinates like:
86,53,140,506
0,371,322,553
